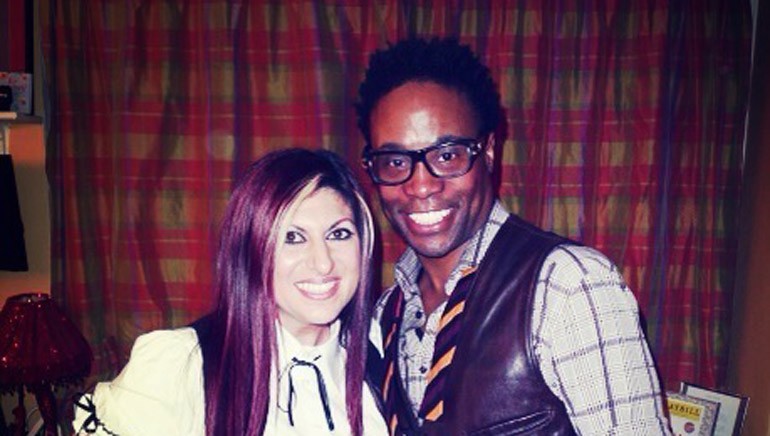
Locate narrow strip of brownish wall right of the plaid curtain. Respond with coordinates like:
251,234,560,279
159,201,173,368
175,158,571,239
730,2,770,436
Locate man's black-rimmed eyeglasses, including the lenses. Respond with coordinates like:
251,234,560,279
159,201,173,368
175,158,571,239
361,138,484,186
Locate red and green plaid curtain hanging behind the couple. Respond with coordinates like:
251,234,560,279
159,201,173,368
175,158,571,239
40,0,751,387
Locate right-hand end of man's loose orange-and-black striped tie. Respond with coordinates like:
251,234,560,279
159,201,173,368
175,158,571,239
420,269,475,421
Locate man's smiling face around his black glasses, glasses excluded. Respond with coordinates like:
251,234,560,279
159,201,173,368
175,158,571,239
371,82,494,258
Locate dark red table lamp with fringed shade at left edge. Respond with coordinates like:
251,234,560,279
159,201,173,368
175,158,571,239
0,294,93,435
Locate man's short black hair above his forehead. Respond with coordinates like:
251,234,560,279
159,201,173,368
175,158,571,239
356,37,502,144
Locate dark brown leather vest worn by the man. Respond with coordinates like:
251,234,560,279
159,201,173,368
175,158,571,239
382,215,575,436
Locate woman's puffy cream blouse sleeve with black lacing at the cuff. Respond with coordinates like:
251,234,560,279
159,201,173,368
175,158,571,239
73,328,205,436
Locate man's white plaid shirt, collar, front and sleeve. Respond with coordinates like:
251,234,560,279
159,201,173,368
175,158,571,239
375,202,669,435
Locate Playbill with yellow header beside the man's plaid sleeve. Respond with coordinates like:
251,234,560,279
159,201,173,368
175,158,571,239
666,392,719,436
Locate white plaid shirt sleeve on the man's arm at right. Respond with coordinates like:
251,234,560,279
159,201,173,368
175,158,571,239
532,245,668,435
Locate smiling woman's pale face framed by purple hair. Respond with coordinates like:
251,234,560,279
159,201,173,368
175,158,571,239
273,188,361,345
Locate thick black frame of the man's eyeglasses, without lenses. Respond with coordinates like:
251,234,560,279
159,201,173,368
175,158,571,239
361,136,486,186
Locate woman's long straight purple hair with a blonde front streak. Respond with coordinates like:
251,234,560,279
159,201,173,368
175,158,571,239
200,149,374,435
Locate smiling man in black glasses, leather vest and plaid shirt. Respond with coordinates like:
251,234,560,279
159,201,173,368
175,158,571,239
356,39,669,435
